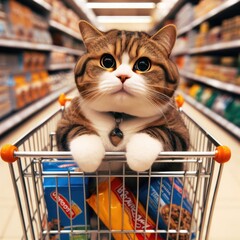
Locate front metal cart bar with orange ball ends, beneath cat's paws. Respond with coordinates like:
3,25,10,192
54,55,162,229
1,144,231,164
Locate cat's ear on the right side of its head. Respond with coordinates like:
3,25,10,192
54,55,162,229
151,24,177,55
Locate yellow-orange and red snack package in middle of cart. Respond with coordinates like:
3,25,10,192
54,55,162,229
87,178,162,240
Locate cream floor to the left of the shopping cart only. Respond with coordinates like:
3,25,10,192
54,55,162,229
0,99,58,240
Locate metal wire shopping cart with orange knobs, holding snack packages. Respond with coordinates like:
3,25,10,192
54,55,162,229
1,95,231,240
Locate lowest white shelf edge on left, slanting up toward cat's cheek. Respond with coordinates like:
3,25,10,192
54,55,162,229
0,85,73,136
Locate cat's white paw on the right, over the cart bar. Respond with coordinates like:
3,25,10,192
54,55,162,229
126,133,163,172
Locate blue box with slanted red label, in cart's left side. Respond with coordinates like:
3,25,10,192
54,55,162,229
43,161,90,240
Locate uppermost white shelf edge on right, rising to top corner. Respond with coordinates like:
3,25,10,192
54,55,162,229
178,0,240,36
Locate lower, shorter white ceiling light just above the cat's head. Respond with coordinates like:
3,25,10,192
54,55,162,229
97,16,152,23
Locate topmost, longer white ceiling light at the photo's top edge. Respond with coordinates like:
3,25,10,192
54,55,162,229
86,2,155,9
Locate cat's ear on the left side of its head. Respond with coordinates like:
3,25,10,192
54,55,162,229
79,20,103,48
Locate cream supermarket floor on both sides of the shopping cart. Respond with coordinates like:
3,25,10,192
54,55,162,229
0,91,240,240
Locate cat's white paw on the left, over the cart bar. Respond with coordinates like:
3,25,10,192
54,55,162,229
70,135,105,172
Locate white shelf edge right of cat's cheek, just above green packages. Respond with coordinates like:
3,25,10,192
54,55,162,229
179,70,240,94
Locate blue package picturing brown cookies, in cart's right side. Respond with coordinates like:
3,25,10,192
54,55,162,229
139,177,196,240
